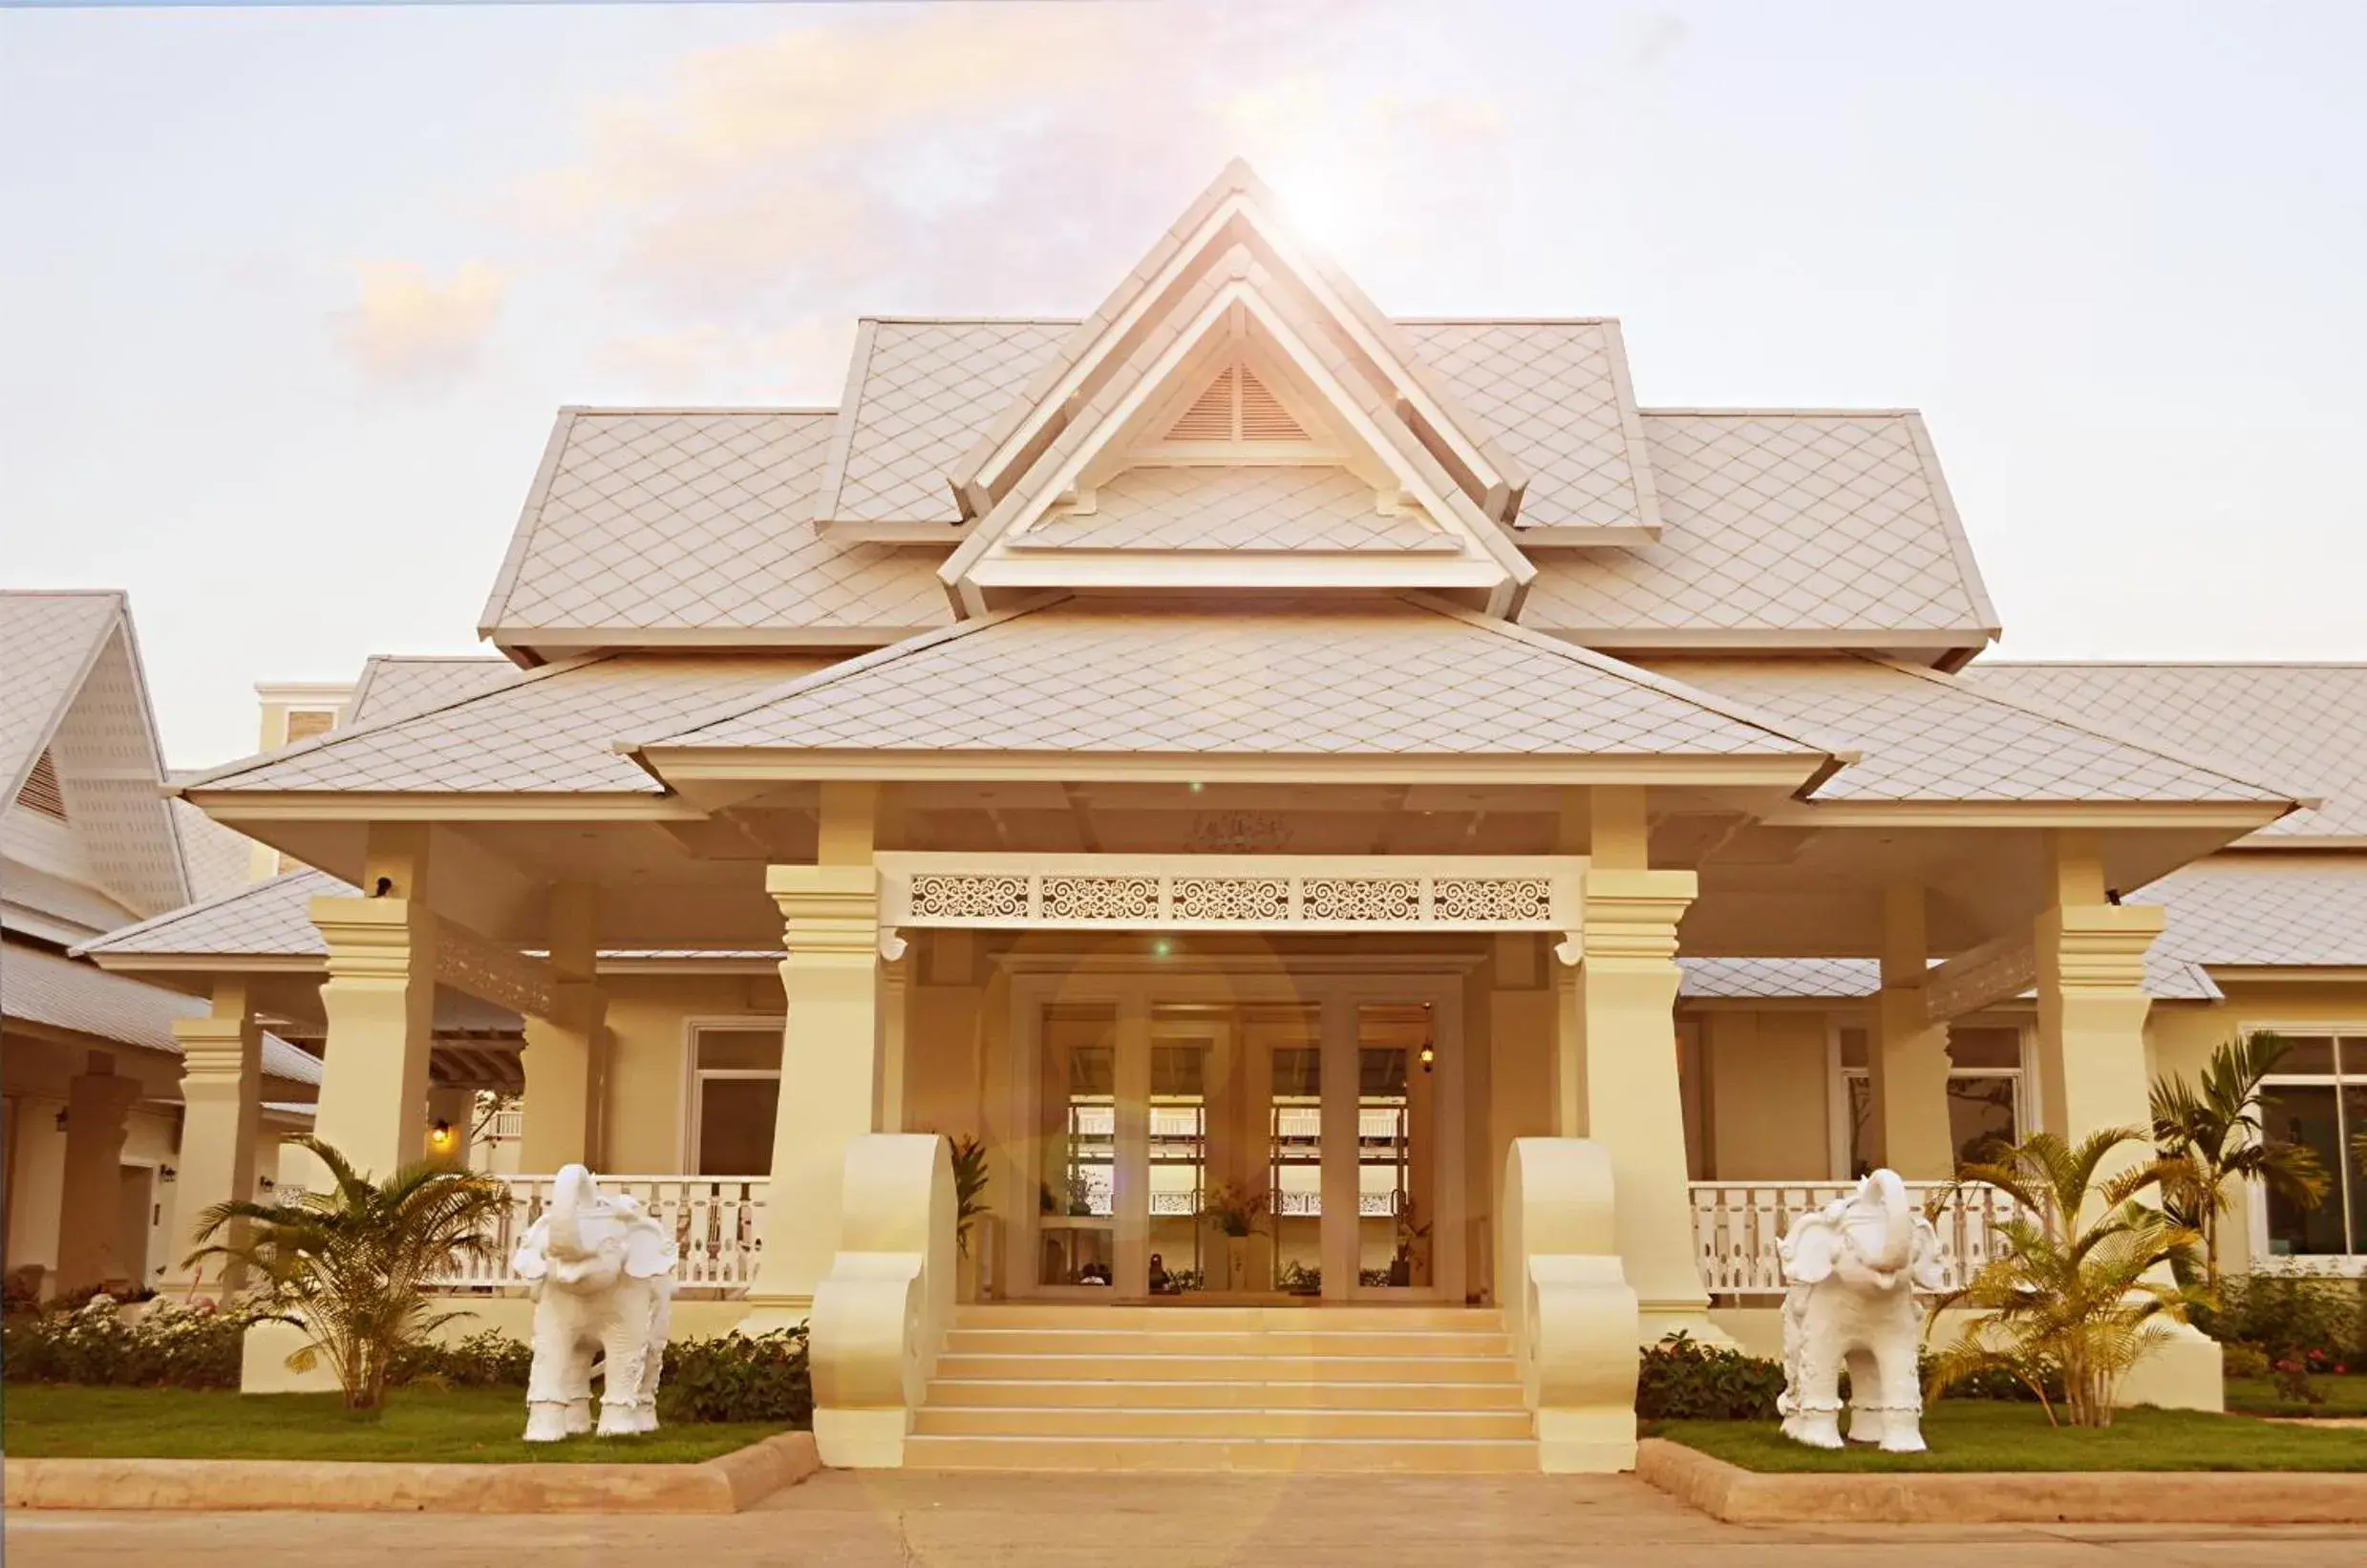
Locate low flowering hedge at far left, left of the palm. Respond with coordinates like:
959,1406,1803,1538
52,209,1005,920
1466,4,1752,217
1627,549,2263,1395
0,1296,253,1388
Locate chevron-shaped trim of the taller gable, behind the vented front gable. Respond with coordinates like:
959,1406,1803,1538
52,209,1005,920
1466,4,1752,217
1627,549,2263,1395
949,159,1526,522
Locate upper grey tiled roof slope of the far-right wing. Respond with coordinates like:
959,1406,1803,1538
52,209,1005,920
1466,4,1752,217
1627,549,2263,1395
1965,660,2367,842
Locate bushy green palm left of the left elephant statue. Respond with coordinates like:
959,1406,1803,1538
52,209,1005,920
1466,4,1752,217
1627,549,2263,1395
189,1137,509,1412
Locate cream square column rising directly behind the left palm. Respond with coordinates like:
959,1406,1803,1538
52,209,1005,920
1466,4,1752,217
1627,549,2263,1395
305,823,436,1187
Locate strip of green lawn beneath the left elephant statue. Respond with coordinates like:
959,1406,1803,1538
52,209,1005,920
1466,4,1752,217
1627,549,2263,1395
0,1384,781,1464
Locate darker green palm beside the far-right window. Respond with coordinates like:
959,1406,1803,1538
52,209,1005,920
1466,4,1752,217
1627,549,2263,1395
2152,1031,2327,1296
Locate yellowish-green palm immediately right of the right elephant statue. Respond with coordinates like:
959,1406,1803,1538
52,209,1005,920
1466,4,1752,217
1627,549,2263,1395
1931,1128,2202,1426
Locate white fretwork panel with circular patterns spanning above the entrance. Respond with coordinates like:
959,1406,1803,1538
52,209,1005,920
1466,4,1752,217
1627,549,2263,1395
878,852,1586,963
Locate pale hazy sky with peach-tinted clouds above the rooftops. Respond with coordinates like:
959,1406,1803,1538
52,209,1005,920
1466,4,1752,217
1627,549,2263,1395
0,0,2367,766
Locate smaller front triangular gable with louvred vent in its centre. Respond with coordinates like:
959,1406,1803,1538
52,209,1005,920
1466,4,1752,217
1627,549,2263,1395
940,246,1536,615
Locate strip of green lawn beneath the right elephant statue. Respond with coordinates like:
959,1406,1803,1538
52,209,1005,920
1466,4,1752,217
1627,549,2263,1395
1645,1400,2367,1471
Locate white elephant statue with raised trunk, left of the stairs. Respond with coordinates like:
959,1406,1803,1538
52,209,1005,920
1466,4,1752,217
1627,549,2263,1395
511,1166,677,1443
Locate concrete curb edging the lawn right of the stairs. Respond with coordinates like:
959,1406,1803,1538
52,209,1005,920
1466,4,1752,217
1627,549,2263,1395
1635,1438,2367,1525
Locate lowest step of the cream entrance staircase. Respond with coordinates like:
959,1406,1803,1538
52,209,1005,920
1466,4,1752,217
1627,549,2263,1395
905,1435,1536,1473
